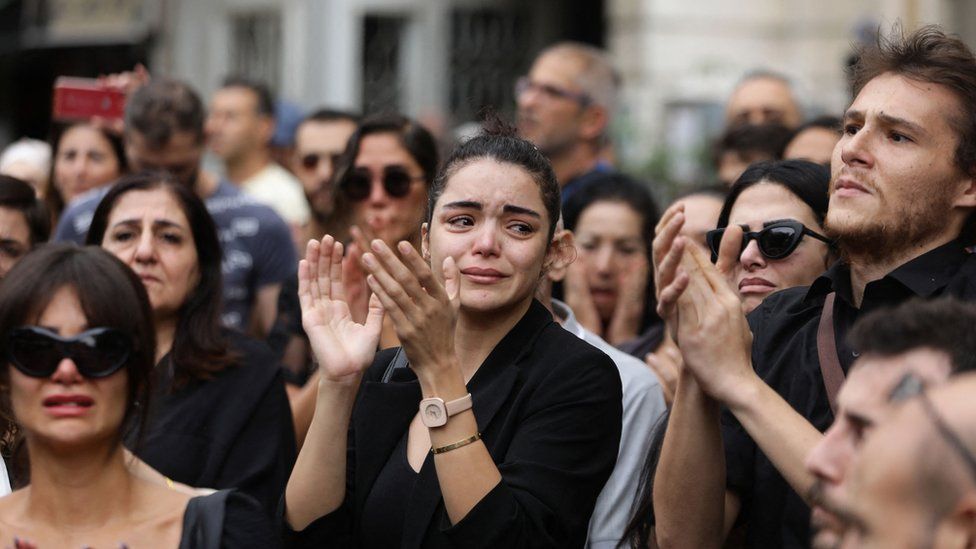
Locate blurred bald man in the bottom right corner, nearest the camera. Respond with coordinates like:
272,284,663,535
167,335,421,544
837,373,976,549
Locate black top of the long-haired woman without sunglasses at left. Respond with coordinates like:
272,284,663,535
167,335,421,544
127,331,296,516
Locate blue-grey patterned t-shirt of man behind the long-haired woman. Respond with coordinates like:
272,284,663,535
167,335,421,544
54,181,298,330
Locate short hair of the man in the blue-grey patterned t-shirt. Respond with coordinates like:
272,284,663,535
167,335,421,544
125,78,206,149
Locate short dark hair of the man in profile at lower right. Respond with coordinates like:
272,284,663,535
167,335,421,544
847,297,976,373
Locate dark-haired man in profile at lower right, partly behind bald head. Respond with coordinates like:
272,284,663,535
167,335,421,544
806,298,976,548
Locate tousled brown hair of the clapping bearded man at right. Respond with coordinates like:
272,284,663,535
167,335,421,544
853,25,976,176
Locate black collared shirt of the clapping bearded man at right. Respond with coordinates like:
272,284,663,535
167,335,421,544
722,241,976,547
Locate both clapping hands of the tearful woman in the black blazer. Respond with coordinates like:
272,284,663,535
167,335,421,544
298,230,460,382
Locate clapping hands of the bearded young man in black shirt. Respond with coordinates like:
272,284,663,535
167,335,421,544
653,204,755,403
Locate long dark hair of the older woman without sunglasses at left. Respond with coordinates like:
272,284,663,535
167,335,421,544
85,172,236,387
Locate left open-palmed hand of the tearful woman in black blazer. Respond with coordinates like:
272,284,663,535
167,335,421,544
298,235,383,382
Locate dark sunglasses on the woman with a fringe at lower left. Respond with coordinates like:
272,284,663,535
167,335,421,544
4,326,132,378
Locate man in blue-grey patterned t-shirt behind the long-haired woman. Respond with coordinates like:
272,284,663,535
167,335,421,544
55,79,297,336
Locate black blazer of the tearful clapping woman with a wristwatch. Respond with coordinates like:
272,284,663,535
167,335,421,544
285,300,622,548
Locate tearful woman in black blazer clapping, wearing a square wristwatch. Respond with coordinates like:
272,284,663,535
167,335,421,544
285,125,621,548
